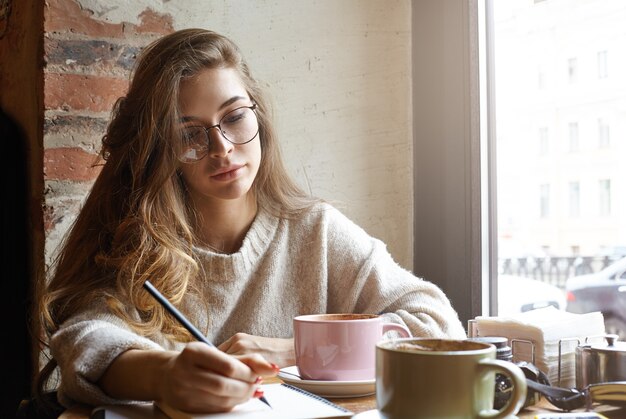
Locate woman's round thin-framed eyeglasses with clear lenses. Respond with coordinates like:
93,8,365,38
178,104,259,163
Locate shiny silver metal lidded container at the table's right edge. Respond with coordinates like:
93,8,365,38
576,335,626,389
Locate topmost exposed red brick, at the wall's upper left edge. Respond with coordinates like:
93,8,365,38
44,0,174,38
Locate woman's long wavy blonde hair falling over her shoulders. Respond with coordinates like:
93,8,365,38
36,29,317,398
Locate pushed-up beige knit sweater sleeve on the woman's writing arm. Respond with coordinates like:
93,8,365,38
50,304,163,407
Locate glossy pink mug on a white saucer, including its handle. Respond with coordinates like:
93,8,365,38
293,314,411,381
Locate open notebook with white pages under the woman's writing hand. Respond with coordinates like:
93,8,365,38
91,384,353,419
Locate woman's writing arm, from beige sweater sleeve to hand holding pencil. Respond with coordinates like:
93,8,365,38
50,308,277,412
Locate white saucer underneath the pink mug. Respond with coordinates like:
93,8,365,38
278,366,376,398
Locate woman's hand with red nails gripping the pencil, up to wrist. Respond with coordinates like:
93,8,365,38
158,342,277,413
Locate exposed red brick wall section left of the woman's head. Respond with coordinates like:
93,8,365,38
43,0,173,262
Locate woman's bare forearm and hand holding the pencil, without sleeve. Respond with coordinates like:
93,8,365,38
99,342,276,413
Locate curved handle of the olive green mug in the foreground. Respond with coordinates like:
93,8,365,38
477,359,526,419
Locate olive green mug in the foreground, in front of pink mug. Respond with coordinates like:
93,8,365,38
376,338,526,419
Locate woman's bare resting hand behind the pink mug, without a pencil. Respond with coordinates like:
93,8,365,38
218,333,296,368
